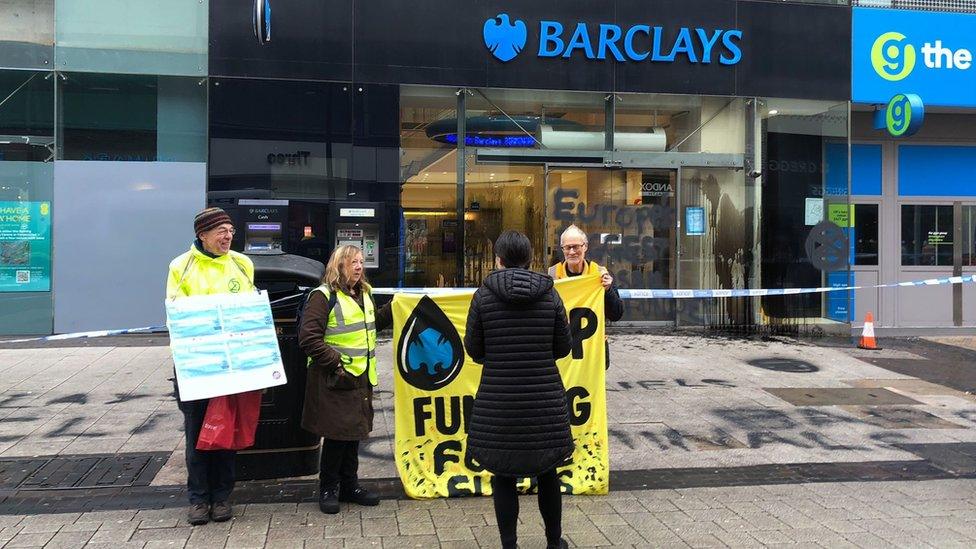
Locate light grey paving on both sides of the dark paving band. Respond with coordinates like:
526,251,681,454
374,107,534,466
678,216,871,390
0,334,976,549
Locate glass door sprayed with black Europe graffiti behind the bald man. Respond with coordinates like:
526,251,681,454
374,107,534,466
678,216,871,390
545,166,678,324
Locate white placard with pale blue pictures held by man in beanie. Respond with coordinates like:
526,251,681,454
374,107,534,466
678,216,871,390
166,291,288,401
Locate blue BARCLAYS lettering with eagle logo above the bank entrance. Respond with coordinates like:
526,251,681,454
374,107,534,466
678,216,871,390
482,13,742,65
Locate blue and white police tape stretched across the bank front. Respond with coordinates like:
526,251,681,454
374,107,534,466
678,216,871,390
0,275,976,345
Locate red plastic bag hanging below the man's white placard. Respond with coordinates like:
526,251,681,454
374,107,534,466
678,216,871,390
197,391,261,450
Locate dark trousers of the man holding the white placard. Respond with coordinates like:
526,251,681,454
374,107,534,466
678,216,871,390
176,396,237,505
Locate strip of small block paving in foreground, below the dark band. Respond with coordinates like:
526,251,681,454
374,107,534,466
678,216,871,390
0,479,976,549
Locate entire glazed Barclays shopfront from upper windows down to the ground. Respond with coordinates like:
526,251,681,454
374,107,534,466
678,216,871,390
400,86,848,326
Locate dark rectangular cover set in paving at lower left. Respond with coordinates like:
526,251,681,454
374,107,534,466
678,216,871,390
0,452,169,490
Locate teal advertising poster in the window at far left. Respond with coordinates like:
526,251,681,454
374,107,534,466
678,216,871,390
0,201,51,292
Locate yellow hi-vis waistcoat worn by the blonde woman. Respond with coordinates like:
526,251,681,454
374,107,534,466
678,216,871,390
309,285,376,385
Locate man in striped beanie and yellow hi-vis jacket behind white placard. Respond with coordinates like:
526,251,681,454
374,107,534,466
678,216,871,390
166,208,255,526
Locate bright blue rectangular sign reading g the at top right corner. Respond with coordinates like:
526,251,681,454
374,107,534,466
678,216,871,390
851,8,976,107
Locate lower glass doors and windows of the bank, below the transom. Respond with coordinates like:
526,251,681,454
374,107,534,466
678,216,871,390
404,150,754,324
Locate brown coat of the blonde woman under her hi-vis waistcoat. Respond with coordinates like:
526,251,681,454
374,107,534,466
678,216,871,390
298,284,393,440
